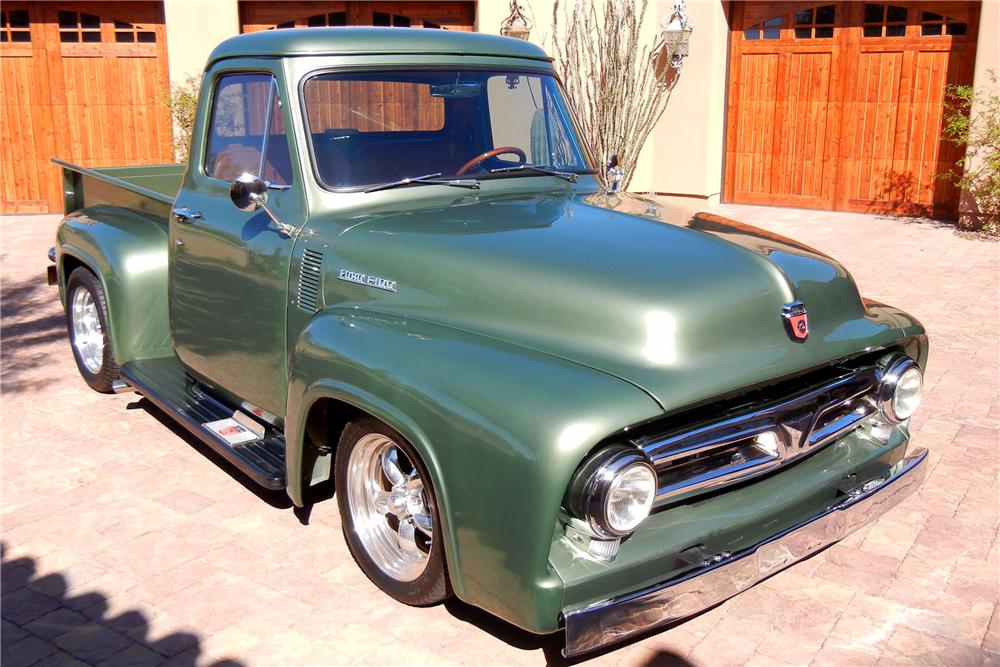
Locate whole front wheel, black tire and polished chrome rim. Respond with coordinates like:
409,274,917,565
334,418,450,606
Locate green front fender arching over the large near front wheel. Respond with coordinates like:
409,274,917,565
286,308,660,632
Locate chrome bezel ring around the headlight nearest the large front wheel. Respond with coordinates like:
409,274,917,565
567,446,657,538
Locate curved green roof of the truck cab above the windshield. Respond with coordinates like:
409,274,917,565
208,28,552,65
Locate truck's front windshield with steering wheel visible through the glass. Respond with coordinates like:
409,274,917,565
303,70,593,188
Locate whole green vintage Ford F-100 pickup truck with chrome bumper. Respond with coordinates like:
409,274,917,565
50,28,927,656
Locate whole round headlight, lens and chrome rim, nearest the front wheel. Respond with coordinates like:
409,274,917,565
572,447,656,537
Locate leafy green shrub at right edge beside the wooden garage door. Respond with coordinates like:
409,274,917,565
942,70,1000,235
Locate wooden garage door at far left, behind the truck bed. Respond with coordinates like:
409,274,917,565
0,2,173,213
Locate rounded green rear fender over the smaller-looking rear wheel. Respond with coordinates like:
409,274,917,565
56,206,173,364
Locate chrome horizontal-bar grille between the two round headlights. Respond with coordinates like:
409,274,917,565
634,367,878,503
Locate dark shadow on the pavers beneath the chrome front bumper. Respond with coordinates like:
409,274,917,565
444,597,694,667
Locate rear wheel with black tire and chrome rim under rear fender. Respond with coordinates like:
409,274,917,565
66,266,118,394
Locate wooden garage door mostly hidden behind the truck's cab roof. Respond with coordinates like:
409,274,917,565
240,0,476,32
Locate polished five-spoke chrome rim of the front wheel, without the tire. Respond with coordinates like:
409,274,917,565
344,433,434,581
